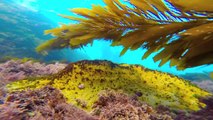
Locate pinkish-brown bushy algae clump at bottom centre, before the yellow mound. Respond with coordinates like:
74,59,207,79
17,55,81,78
92,91,172,120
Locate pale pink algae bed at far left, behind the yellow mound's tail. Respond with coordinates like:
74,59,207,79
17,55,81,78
0,60,66,81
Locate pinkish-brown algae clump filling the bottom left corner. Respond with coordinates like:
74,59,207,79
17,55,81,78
0,86,97,120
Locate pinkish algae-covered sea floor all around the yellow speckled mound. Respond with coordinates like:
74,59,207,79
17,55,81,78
0,60,213,120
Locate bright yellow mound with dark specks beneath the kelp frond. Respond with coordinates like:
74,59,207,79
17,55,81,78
7,61,211,111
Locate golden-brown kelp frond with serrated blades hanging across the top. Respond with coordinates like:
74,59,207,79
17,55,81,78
37,0,213,69
